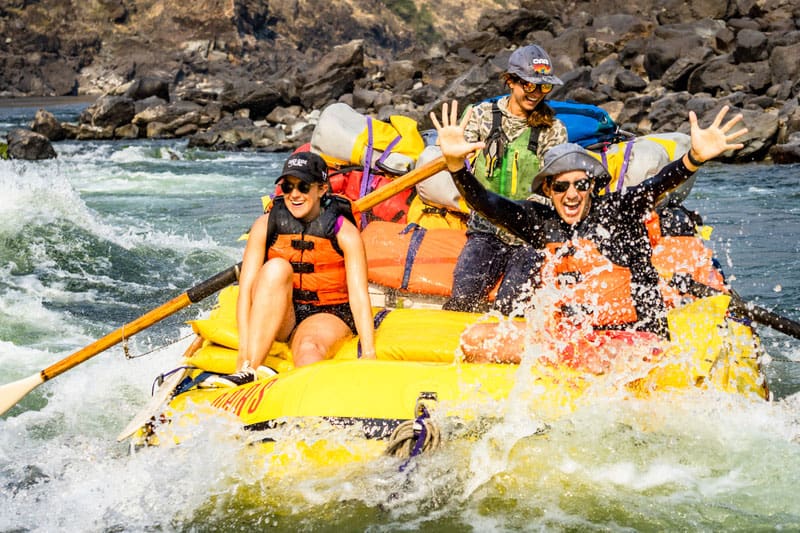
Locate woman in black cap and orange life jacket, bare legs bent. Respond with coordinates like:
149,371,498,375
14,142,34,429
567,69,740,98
214,152,375,386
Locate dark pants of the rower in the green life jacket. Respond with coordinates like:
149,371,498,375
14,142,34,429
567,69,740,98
443,232,544,315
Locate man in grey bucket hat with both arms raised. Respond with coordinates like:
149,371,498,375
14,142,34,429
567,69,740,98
431,102,747,357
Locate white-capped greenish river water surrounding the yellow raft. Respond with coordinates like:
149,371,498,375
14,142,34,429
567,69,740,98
0,104,800,532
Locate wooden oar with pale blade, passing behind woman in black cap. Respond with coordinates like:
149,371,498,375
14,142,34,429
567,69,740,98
0,157,447,415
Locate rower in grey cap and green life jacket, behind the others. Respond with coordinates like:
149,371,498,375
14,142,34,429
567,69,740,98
444,45,567,314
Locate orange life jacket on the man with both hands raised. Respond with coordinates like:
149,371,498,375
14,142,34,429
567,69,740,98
541,238,639,327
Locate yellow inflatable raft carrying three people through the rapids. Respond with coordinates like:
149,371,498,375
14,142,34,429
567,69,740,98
129,286,767,465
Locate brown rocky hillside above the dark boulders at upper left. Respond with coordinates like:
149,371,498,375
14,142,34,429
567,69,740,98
0,0,488,97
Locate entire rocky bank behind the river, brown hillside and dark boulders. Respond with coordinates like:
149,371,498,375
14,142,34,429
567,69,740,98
0,0,800,162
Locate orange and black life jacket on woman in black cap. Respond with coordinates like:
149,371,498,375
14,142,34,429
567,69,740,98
266,194,355,305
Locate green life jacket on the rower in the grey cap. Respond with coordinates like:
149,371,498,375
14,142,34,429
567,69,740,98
473,102,540,200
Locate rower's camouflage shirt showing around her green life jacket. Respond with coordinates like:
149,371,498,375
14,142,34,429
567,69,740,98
464,96,567,246
